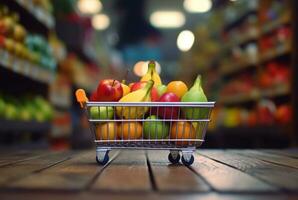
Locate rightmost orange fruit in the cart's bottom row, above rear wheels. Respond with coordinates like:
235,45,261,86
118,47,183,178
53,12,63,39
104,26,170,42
170,122,196,146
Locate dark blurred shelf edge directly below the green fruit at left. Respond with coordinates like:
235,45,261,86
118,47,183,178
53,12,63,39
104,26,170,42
0,119,51,132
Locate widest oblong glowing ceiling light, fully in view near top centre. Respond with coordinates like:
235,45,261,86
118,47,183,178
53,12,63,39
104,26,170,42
150,11,185,28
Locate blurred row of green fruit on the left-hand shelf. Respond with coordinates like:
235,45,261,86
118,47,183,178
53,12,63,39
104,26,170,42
0,94,53,122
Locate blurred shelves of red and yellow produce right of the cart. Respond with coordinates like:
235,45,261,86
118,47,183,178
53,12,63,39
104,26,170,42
185,0,293,145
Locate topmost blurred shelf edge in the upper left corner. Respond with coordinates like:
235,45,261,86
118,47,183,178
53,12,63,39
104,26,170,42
14,0,55,29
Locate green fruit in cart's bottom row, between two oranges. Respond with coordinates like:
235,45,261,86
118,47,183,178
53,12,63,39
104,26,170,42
143,115,169,139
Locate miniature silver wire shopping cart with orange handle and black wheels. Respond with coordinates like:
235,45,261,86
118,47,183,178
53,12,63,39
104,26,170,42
76,89,215,166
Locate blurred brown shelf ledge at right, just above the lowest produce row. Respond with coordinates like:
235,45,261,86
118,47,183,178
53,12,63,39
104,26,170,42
219,85,290,105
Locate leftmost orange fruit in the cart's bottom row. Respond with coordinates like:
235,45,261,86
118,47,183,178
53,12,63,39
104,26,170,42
96,122,117,140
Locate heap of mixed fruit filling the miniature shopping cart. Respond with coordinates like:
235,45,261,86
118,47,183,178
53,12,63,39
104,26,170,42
90,61,209,145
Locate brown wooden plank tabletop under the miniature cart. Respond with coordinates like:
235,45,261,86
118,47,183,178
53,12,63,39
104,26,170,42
0,150,298,200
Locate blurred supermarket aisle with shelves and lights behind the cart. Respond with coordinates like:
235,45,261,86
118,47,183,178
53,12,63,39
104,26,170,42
0,0,298,150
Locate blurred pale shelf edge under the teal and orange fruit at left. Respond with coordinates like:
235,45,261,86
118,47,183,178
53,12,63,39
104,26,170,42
0,49,54,84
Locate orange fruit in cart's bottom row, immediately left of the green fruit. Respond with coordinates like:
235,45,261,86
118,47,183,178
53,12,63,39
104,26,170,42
117,122,143,140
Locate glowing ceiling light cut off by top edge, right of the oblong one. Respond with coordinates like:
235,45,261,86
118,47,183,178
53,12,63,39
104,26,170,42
183,0,212,13
